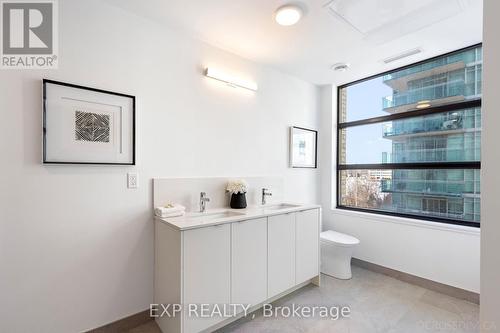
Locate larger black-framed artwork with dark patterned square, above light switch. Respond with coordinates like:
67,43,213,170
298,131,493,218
43,79,135,165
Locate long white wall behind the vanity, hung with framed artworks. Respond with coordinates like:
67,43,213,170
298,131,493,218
0,0,318,333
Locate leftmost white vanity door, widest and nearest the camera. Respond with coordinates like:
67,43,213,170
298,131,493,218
182,224,231,333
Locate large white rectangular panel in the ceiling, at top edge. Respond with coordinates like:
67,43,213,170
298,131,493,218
325,0,470,44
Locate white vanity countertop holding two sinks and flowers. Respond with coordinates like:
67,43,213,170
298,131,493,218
155,203,321,231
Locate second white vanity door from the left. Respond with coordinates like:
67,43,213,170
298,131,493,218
231,218,267,306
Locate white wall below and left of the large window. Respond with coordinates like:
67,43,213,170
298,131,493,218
320,86,484,292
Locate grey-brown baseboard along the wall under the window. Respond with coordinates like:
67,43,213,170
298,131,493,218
352,258,479,304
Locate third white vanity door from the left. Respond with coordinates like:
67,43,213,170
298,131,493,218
267,213,295,297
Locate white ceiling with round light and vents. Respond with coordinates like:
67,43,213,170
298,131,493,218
105,0,482,85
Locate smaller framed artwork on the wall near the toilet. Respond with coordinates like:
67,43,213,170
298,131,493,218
290,126,318,168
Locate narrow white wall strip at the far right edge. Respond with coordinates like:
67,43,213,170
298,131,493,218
481,0,500,332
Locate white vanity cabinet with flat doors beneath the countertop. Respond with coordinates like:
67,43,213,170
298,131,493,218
154,206,321,333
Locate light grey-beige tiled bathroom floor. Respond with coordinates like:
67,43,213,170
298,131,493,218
130,266,479,333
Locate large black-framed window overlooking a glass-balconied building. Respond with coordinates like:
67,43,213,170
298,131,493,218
337,45,482,227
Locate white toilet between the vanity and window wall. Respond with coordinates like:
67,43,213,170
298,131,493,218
320,230,359,280
